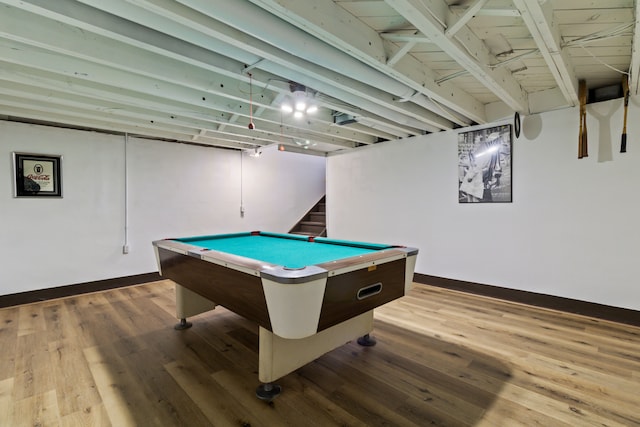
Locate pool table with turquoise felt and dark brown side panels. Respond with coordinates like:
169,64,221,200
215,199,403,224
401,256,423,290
153,231,418,400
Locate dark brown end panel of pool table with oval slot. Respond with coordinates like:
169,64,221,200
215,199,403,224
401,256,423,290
318,258,406,331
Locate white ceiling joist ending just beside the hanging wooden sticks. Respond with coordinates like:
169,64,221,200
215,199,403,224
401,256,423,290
513,0,579,107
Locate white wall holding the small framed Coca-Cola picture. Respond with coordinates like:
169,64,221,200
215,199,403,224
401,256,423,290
0,121,325,295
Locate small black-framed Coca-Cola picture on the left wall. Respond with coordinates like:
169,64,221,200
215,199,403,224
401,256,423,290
13,152,62,197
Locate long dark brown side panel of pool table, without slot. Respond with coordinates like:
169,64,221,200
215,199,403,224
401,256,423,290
158,248,271,330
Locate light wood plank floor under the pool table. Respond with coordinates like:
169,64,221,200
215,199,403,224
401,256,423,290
0,281,640,427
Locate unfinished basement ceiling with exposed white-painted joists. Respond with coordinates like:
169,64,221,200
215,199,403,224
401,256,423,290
0,0,640,155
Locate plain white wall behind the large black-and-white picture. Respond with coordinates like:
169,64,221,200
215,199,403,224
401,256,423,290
327,98,640,310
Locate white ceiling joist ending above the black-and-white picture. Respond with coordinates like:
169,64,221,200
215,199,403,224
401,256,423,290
385,0,529,113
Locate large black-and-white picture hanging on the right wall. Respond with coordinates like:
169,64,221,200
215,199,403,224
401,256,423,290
458,125,511,203
